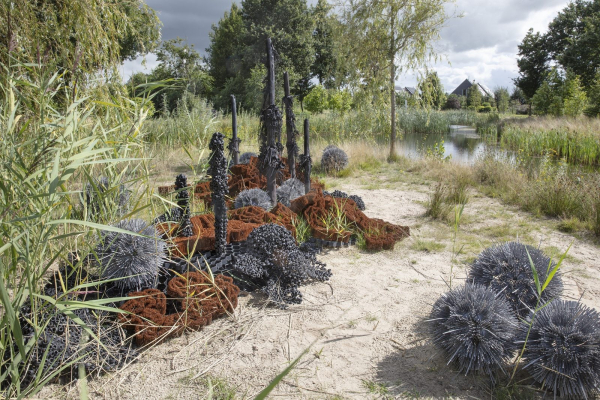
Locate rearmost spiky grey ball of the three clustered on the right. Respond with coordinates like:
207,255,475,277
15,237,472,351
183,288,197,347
467,242,563,318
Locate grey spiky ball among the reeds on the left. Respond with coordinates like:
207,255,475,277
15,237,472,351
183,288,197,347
94,219,166,291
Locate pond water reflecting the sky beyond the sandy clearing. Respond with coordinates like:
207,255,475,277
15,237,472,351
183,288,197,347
397,125,508,164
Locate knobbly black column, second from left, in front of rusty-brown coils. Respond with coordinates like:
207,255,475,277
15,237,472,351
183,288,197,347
208,132,229,254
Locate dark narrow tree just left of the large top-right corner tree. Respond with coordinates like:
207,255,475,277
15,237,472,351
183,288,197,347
514,29,550,108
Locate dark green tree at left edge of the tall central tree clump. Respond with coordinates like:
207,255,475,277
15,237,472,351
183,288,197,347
204,3,246,107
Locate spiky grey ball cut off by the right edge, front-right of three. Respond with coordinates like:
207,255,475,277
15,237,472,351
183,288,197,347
517,300,600,399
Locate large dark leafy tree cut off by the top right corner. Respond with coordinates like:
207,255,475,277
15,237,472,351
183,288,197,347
545,0,600,86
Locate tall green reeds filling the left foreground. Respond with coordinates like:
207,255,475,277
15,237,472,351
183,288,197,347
0,61,159,398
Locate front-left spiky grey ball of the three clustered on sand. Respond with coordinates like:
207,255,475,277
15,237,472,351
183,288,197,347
429,284,517,380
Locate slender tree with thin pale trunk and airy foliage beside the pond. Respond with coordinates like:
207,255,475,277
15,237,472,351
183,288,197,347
342,0,454,158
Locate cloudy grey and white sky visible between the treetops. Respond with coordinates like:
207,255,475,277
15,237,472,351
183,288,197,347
122,0,569,92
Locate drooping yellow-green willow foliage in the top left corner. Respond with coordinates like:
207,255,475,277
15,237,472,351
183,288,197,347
0,0,160,73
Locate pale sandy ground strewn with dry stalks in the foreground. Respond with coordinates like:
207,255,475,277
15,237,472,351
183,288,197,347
39,177,600,399
